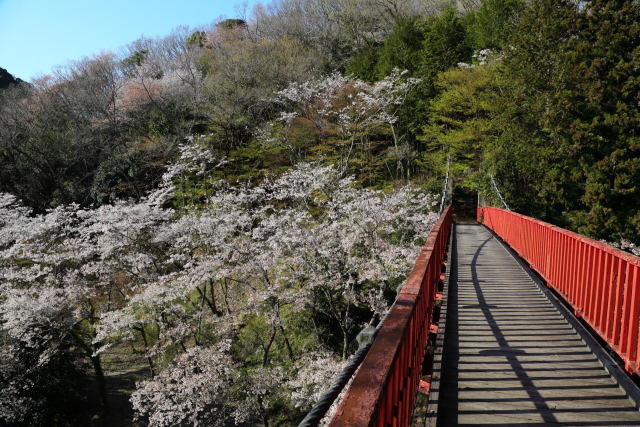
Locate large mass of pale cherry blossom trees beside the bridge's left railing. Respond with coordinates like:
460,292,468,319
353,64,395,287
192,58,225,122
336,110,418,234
0,131,437,426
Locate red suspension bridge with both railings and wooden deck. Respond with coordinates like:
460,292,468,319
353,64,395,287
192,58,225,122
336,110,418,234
322,207,640,426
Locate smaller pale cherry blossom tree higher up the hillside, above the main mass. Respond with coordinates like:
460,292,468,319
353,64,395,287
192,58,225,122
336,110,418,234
258,69,420,178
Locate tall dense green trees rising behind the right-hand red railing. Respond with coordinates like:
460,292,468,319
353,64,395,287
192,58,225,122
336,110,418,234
488,0,640,241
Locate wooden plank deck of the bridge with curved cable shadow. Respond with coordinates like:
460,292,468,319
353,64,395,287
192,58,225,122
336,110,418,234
429,225,640,426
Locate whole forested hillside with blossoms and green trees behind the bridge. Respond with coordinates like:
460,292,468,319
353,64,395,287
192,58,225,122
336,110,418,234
0,0,640,426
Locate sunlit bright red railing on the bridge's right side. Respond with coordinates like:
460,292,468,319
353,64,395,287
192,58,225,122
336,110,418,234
478,207,640,373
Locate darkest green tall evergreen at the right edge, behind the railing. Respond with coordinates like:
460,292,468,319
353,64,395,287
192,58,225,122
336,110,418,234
553,1,640,241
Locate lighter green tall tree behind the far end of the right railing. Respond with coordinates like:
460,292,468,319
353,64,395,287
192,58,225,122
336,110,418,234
472,2,576,222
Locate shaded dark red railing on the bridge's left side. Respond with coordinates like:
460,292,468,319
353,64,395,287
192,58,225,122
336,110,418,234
330,207,451,426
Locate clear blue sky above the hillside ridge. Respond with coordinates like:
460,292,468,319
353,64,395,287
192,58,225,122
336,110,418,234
0,0,257,80
